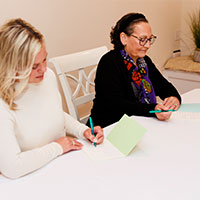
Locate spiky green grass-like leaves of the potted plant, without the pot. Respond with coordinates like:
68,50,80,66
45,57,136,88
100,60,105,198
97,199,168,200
190,8,200,49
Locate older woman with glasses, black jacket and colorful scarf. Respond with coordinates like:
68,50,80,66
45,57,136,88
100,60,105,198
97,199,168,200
87,13,181,127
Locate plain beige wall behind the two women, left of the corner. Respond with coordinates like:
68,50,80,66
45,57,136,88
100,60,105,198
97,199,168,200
0,0,182,67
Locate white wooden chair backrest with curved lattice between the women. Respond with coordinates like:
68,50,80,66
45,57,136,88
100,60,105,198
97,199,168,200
49,46,108,123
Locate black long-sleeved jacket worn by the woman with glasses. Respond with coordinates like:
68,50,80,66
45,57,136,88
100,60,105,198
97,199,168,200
87,50,181,127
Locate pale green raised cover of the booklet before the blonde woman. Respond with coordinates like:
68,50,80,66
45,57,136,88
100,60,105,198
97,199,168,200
107,115,146,156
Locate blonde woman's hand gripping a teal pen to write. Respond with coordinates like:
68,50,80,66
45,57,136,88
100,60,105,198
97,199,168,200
83,126,104,144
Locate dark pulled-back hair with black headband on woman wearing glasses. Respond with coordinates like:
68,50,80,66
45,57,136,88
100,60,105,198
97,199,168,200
110,13,148,49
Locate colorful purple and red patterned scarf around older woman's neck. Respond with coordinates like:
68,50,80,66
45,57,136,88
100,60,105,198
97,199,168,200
120,49,156,104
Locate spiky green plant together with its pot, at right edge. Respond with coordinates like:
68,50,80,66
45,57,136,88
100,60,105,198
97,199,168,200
190,8,200,62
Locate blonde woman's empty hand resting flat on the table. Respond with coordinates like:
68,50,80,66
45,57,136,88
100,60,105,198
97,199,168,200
56,136,83,153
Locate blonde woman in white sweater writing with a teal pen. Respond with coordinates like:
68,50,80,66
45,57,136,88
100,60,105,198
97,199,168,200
0,19,103,178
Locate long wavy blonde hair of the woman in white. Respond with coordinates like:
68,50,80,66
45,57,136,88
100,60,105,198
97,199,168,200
0,19,44,110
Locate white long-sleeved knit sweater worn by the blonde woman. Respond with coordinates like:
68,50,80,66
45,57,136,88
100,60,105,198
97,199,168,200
0,69,88,178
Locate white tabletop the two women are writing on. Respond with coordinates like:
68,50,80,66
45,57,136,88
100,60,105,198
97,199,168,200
0,89,200,200
